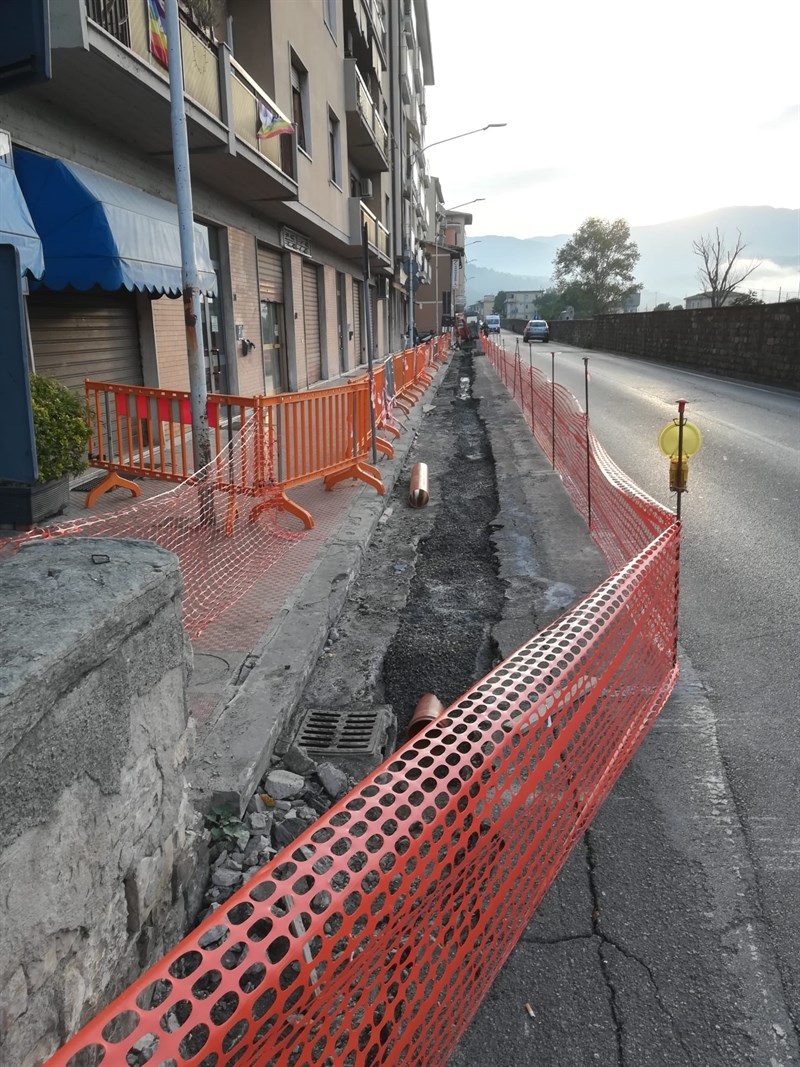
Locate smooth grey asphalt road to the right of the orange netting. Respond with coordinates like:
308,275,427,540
488,334,800,1064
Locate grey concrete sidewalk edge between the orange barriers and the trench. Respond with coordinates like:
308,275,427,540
183,364,456,809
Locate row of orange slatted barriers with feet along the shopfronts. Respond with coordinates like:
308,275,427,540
85,337,452,528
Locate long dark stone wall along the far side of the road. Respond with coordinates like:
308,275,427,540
541,301,800,389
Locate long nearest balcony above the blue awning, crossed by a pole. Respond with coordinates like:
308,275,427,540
30,0,298,207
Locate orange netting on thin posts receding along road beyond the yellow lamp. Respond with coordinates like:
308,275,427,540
484,341,675,568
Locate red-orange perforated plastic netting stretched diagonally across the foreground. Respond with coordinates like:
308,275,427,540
48,328,681,1067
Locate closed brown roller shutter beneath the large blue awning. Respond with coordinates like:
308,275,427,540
28,291,142,393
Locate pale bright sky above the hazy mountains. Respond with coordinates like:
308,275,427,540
426,0,800,237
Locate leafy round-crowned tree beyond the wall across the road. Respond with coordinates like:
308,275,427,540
553,218,642,315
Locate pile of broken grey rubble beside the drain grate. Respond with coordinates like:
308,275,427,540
198,745,356,922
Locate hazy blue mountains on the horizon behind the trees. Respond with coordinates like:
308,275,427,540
466,207,800,309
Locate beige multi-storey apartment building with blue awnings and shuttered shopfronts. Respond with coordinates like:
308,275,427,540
0,0,433,403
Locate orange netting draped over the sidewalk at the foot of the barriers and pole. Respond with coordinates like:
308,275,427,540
2,411,303,639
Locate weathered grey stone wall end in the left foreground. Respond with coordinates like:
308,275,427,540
0,538,207,1067
